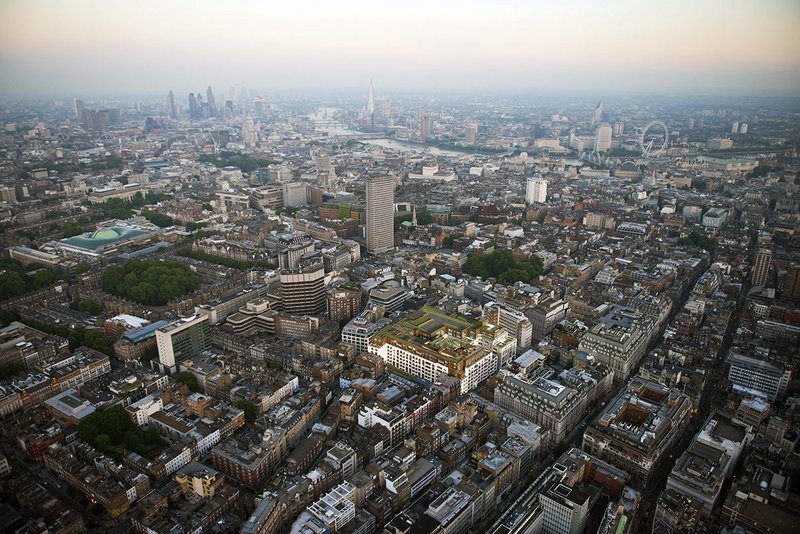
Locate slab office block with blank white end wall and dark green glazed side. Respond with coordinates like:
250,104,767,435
156,315,211,374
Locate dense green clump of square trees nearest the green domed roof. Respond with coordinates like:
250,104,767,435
102,260,200,306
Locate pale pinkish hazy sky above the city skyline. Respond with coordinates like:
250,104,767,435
0,0,800,97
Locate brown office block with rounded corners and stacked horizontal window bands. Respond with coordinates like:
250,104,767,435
280,258,326,315
